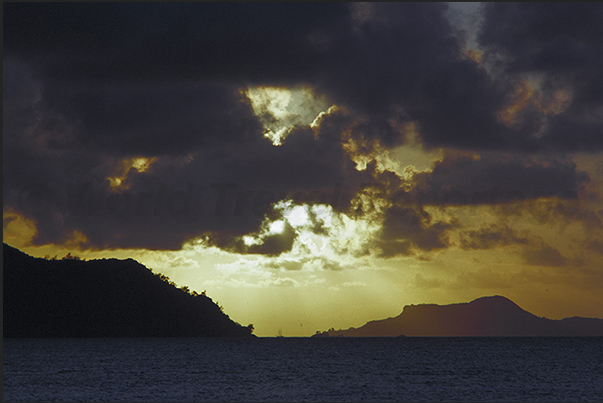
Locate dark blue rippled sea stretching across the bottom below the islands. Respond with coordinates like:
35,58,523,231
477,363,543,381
3,338,603,401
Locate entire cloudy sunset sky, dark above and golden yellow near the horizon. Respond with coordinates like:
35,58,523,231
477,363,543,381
3,2,603,337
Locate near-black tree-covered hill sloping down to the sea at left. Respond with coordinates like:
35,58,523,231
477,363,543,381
3,244,255,338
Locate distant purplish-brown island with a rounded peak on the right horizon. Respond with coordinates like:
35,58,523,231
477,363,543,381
313,295,603,337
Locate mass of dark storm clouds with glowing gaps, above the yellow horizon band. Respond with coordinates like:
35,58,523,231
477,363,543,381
3,3,603,261
